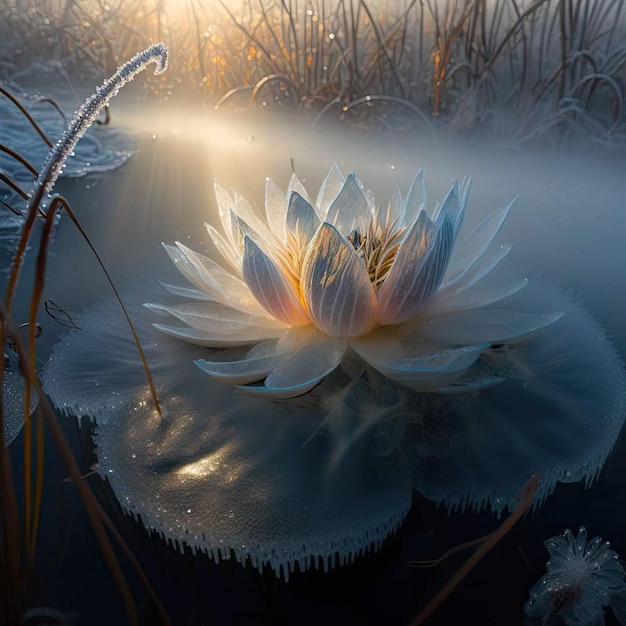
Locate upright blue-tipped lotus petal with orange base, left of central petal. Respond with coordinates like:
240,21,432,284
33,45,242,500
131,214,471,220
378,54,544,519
242,237,310,326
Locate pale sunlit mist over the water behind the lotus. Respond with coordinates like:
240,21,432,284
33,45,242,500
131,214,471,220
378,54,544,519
48,101,626,338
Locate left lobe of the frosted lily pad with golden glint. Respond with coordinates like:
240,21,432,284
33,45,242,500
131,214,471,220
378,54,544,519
44,296,411,577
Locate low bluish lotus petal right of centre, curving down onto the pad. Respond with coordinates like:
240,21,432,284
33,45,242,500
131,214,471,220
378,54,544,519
350,335,482,391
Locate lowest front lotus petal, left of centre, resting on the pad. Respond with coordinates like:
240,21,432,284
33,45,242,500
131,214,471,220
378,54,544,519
239,338,347,398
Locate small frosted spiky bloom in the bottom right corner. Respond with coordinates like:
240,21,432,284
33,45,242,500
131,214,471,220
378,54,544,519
524,527,626,626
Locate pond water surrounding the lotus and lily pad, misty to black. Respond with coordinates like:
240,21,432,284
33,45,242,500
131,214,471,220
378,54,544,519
7,113,626,625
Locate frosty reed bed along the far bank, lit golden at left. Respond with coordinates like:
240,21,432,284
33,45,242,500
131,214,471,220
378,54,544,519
0,0,626,144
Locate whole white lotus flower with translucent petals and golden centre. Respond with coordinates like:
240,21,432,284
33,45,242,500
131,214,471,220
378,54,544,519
146,166,561,398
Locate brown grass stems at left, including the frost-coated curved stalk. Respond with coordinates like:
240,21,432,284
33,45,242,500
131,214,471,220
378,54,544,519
0,46,168,624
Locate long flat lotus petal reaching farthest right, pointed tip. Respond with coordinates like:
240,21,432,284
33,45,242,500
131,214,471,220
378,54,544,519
421,309,563,345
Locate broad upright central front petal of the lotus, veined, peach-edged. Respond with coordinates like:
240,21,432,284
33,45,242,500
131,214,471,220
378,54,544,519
300,222,376,337
